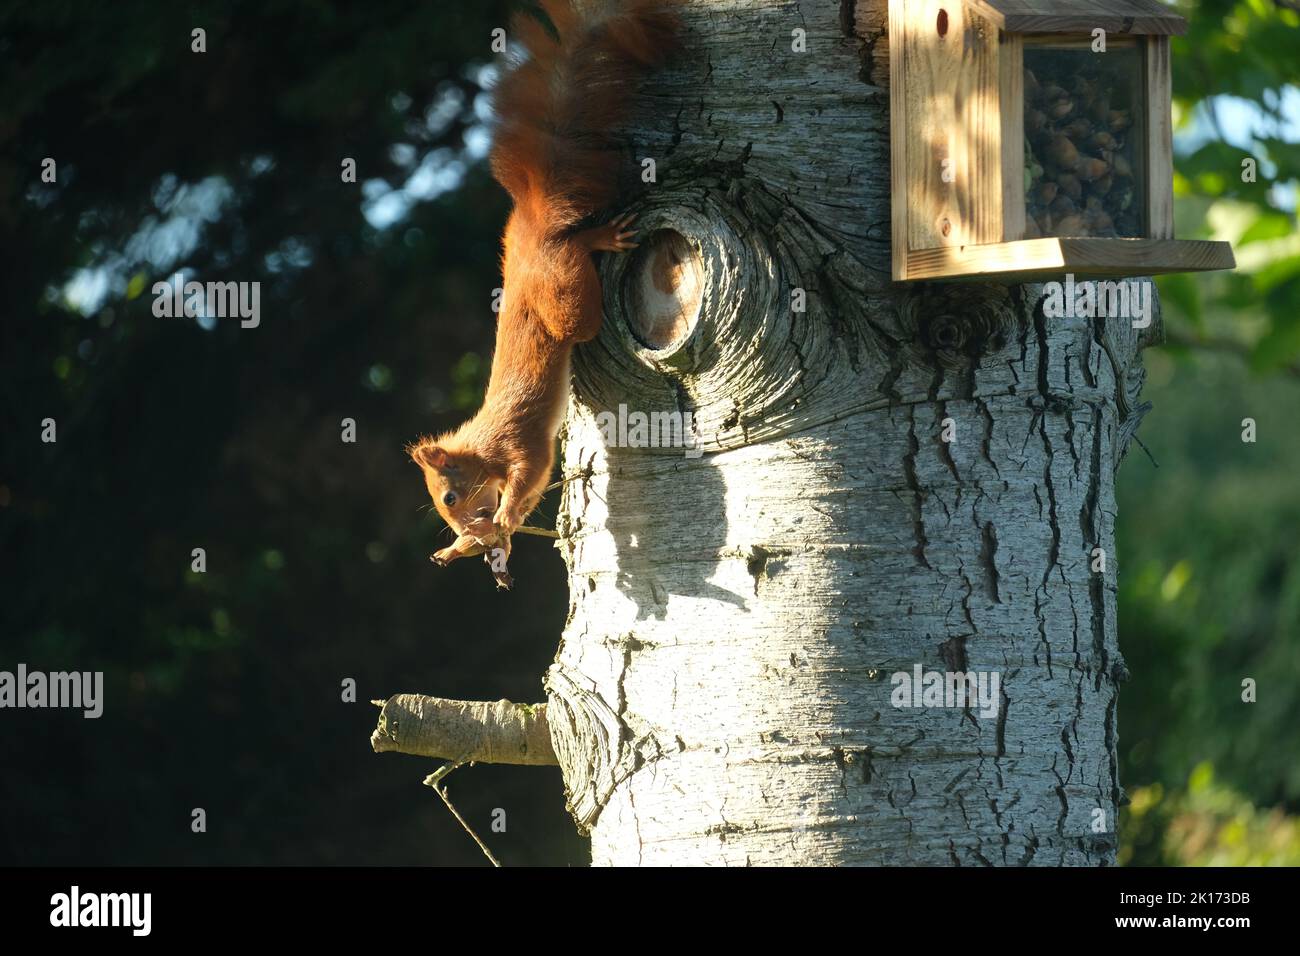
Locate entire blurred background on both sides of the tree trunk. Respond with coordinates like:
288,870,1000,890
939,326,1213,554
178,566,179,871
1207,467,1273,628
0,0,1300,865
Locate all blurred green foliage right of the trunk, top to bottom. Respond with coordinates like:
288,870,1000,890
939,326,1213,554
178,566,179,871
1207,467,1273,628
1117,0,1300,865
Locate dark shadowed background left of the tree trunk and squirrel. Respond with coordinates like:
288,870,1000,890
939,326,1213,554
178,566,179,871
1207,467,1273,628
0,3,585,864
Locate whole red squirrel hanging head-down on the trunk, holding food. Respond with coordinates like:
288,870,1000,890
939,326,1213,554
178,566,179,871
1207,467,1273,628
408,0,679,587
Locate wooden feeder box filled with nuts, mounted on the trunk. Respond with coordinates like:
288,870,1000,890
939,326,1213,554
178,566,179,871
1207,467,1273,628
889,0,1236,281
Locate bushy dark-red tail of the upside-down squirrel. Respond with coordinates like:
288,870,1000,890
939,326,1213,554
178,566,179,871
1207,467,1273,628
491,0,679,229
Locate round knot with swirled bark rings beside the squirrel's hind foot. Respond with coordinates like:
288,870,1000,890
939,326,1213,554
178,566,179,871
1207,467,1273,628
587,193,798,447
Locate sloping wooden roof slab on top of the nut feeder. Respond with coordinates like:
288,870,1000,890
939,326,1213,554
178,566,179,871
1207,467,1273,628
966,0,1187,34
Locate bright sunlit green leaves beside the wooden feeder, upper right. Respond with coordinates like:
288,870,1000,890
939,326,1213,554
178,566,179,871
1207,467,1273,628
1157,0,1300,372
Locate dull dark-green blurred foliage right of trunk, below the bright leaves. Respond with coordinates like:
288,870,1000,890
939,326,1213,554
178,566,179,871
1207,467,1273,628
1117,350,1300,864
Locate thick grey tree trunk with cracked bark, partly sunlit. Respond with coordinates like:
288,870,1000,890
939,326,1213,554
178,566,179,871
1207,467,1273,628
546,0,1160,865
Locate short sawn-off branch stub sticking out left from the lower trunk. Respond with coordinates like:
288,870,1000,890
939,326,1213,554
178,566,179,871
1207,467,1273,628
371,693,558,766
